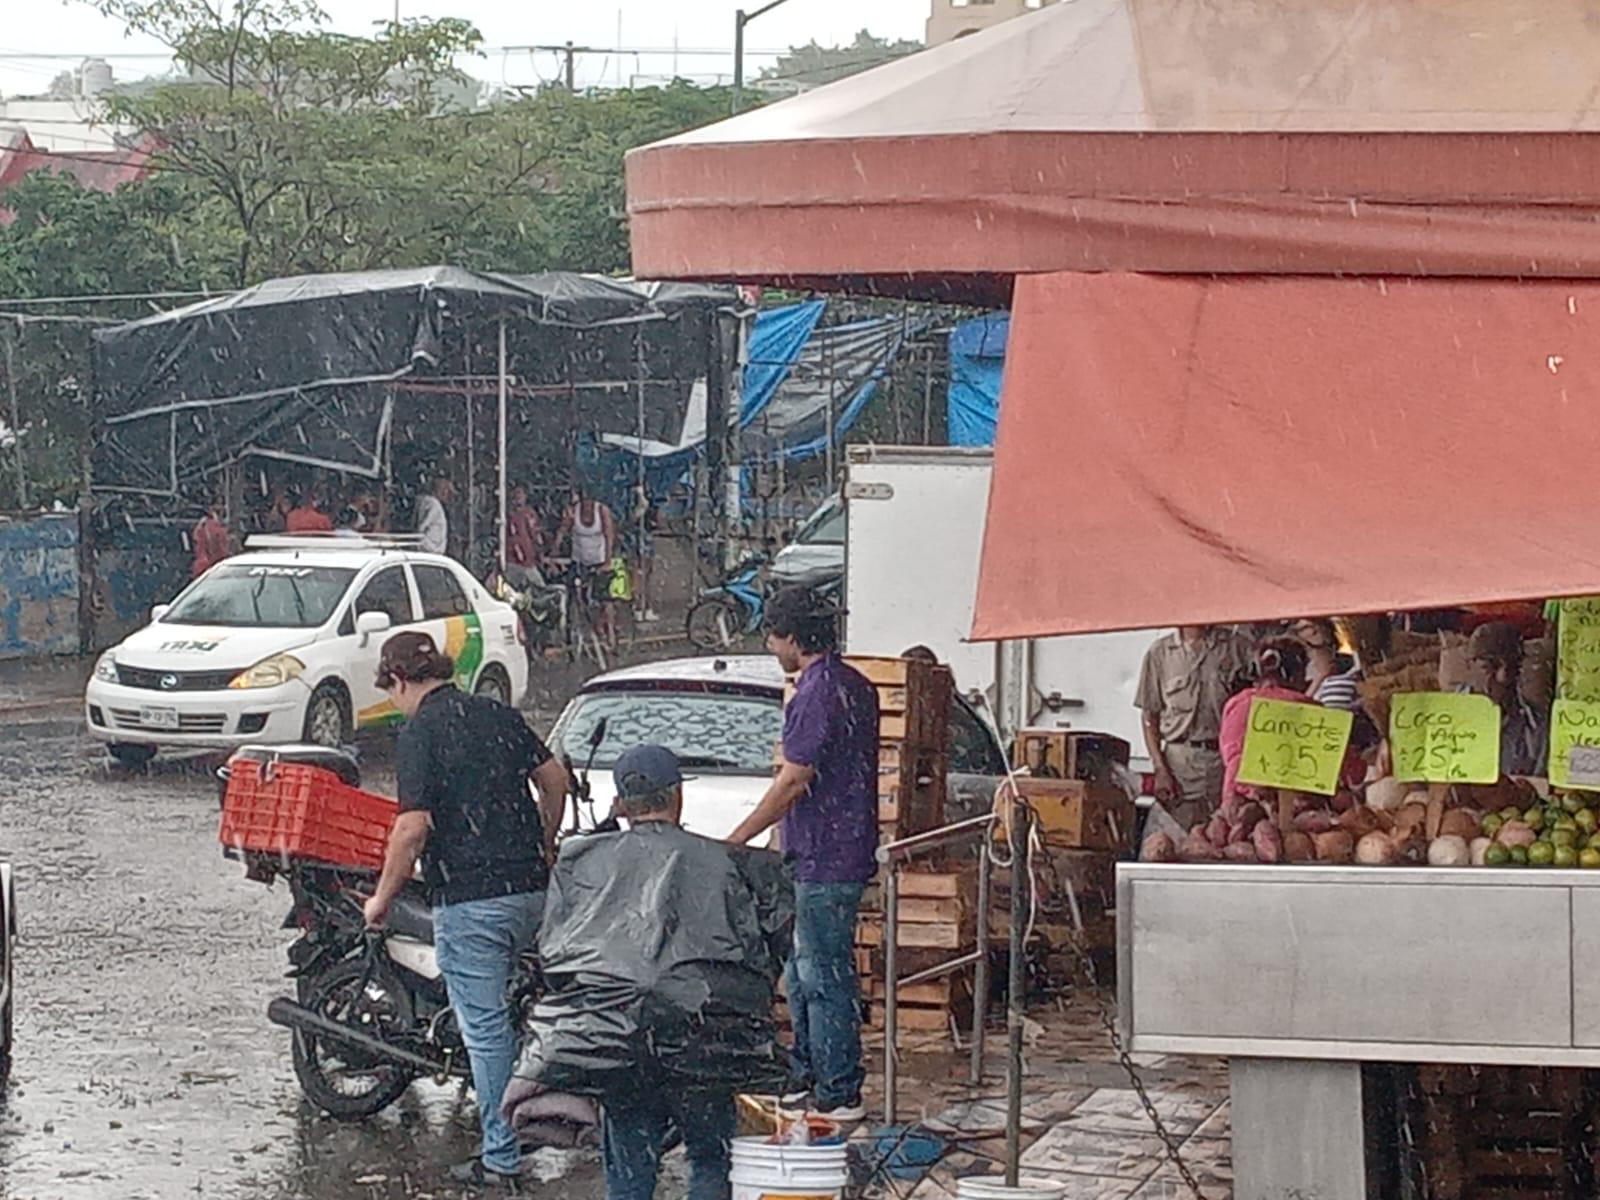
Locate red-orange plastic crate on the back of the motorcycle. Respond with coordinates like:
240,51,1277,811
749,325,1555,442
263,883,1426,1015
219,760,398,870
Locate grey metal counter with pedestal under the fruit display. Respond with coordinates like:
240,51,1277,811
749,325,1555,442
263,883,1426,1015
1117,862,1600,1200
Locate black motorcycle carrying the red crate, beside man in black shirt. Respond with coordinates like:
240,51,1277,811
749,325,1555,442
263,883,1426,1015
222,722,606,1120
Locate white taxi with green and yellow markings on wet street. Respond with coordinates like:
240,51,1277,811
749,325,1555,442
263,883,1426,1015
85,536,528,765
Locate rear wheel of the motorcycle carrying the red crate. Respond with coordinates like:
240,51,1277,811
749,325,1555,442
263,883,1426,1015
293,958,416,1122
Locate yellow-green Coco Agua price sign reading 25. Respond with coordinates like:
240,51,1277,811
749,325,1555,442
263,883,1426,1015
1389,691,1499,784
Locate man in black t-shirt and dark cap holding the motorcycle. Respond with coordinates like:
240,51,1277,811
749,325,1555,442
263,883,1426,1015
366,632,566,1189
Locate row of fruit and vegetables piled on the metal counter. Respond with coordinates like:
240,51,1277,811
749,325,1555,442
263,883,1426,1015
1141,779,1600,870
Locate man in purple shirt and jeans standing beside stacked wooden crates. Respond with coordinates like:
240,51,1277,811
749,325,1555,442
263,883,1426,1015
730,587,878,1122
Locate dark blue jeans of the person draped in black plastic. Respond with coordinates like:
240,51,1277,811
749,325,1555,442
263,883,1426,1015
602,1088,736,1200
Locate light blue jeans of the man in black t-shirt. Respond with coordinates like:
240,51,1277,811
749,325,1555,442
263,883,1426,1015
434,891,544,1174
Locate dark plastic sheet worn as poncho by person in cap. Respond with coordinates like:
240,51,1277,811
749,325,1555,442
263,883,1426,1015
517,822,794,1096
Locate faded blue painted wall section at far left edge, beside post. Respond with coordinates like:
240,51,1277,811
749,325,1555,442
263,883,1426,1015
0,512,80,659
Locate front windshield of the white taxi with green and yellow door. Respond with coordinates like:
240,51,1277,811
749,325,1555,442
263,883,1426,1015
162,563,355,629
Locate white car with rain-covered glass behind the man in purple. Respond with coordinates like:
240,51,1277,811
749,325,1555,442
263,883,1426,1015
550,654,1006,837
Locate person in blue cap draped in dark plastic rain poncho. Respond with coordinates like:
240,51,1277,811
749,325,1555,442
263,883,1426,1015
506,746,794,1200
